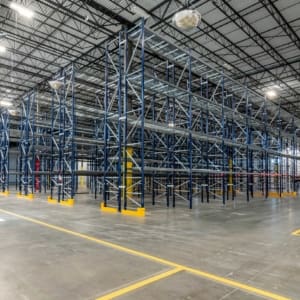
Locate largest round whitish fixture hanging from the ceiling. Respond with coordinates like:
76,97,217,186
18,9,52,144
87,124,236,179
172,9,201,30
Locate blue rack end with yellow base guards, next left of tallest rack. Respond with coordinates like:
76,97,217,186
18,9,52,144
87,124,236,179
49,65,76,205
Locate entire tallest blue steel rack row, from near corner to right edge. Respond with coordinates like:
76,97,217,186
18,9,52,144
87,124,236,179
99,20,300,211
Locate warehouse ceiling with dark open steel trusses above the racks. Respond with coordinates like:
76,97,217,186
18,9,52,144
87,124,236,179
0,0,300,117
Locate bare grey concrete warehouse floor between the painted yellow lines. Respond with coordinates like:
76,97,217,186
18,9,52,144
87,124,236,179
0,195,300,300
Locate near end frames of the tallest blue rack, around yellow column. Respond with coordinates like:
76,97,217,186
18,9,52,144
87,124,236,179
103,22,145,211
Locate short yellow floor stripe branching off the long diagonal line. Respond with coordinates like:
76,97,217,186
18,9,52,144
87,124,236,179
96,268,182,300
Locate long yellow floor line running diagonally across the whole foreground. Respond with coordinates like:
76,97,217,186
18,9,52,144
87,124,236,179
0,209,291,300
